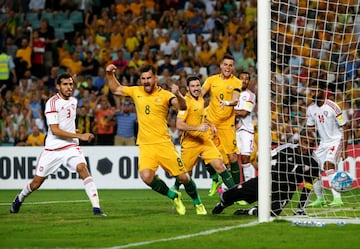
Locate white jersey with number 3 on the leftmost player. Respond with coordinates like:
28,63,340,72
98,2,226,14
45,94,79,150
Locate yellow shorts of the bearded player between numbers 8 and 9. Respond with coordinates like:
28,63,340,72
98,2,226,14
181,140,222,171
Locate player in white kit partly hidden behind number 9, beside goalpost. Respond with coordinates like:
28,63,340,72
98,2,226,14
234,72,256,181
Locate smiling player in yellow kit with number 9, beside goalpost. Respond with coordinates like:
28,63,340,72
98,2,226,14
202,54,242,184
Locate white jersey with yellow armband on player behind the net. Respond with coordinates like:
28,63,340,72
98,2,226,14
306,99,346,143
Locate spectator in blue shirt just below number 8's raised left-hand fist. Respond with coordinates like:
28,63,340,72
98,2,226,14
115,100,137,146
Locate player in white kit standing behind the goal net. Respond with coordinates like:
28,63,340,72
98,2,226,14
306,80,348,207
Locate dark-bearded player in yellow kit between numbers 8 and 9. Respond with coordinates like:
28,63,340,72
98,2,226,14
174,76,235,193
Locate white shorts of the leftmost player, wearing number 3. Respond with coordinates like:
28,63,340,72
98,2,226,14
35,146,87,177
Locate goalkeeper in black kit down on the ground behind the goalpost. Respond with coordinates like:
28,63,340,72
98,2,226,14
212,130,319,215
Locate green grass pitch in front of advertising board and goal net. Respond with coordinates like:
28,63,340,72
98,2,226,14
0,189,360,249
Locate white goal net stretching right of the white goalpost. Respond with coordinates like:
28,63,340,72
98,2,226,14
258,0,360,221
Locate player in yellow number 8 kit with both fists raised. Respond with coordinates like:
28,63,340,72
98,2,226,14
106,64,206,215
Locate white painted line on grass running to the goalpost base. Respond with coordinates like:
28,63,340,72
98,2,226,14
103,221,259,249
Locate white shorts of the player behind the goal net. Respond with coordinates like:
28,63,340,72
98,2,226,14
315,140,342,170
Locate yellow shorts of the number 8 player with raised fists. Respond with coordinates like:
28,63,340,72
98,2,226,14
139,141,187,176
